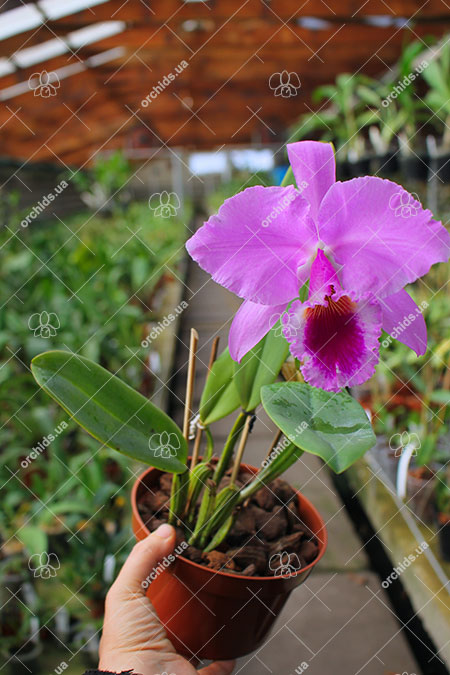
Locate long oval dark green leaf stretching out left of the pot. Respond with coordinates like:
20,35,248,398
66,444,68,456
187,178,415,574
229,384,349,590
31,351,188,473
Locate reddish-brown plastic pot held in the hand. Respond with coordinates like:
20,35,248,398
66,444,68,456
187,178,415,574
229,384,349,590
131,464,327,660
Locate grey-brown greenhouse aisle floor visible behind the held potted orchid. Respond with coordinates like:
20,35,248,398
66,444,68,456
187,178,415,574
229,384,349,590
171,255,419,675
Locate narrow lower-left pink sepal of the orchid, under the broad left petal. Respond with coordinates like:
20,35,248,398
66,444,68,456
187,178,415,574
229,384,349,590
228,300,286,362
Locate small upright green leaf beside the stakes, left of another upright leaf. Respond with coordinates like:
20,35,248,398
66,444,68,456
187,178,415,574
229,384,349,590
200,347,240,425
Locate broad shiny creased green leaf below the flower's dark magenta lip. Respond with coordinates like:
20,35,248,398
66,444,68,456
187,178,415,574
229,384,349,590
262,382,376,473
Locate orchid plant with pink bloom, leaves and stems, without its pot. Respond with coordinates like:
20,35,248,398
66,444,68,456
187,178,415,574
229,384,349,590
32,141,450,551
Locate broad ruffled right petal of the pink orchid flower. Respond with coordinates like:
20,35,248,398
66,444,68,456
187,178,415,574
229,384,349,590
318,176,450,298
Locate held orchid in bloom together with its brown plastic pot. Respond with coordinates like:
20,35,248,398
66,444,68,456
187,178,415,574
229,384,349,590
32,141,450,659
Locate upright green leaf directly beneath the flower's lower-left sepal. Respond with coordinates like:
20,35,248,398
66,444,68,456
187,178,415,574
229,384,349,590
234,321,289,411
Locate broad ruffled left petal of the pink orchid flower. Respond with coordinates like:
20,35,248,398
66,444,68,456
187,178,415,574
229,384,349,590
186,185,317,305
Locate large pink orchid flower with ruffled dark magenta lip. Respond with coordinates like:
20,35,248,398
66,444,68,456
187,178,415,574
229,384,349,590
186,141,450,391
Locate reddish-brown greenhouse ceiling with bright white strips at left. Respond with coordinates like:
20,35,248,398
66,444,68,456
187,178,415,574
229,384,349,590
0,0,450,165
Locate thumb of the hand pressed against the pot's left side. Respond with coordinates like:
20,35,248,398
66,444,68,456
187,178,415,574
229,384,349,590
110,524,175,596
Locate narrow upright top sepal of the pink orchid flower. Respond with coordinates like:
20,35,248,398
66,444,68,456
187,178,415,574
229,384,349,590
287,141,336,219
